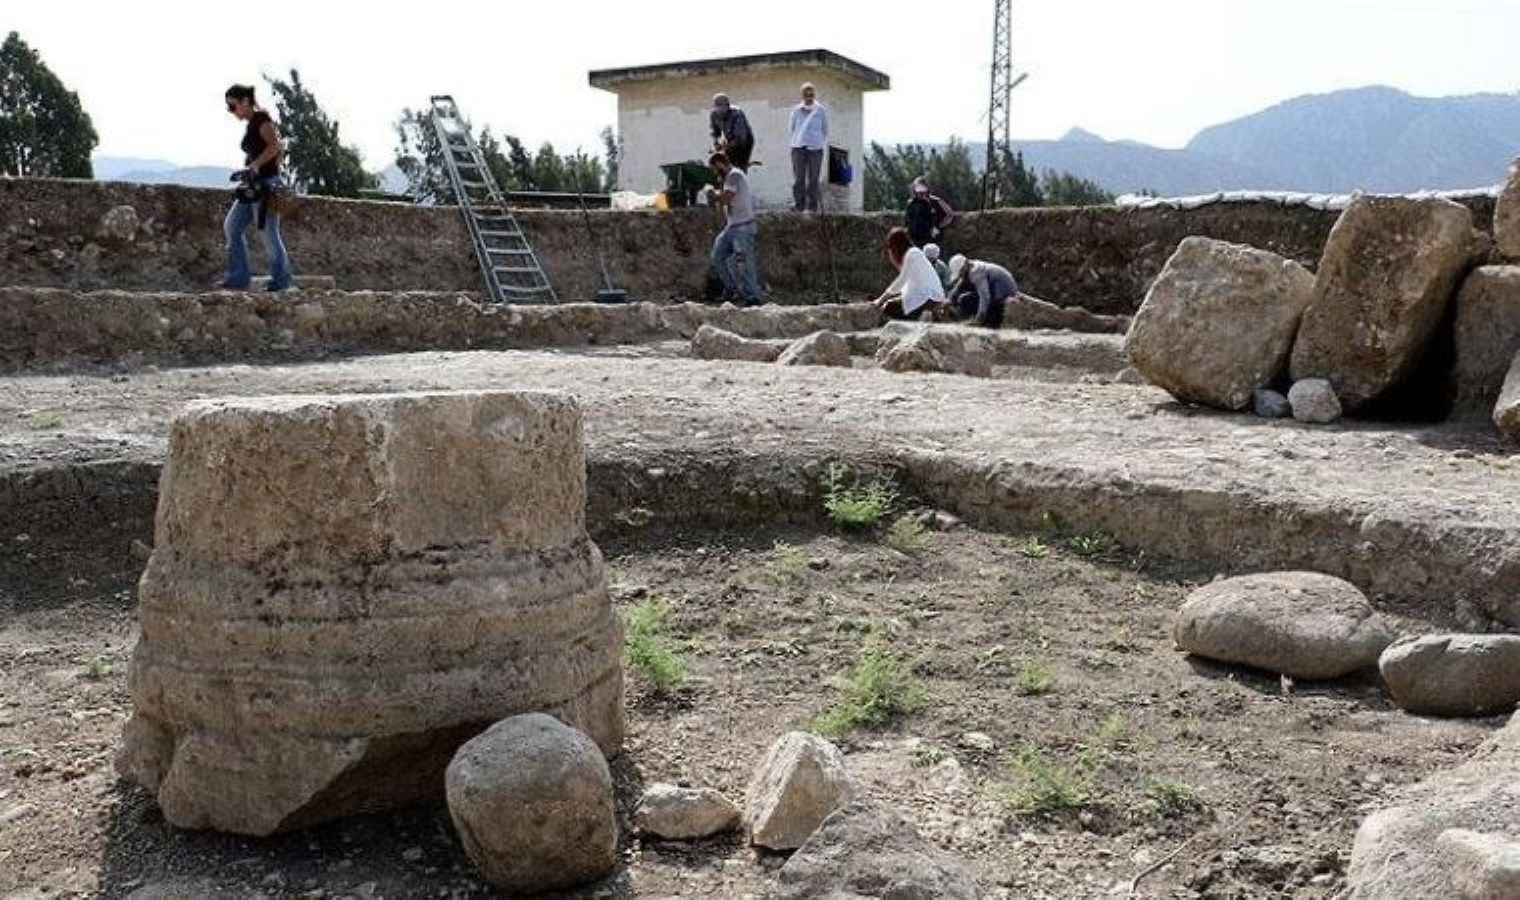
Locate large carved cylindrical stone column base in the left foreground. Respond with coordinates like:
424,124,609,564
117,392,623,835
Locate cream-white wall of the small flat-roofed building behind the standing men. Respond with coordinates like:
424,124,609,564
613,67,865,213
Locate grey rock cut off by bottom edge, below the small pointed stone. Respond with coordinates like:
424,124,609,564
771,801,982,900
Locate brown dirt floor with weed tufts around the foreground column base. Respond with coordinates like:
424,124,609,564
0,528,1500,898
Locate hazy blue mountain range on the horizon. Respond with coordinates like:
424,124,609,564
94,87,1520,196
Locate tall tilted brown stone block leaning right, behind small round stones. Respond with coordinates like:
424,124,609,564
1289,196,1477,412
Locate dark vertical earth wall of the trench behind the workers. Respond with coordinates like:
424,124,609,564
0,178,1493,315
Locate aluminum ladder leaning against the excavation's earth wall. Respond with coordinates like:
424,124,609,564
432,96,558,303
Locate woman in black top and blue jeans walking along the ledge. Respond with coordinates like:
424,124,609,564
222,85,293,290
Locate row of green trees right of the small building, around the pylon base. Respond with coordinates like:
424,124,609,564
865,138,1114,210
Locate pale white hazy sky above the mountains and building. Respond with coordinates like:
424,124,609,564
0,0,1520,169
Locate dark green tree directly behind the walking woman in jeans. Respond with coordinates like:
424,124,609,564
264,68,378,198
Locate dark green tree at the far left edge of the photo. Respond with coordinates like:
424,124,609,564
0,32,100,178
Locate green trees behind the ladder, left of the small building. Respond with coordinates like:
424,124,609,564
395,109,617,204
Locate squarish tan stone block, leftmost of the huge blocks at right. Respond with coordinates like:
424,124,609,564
1125,237,1315,409
